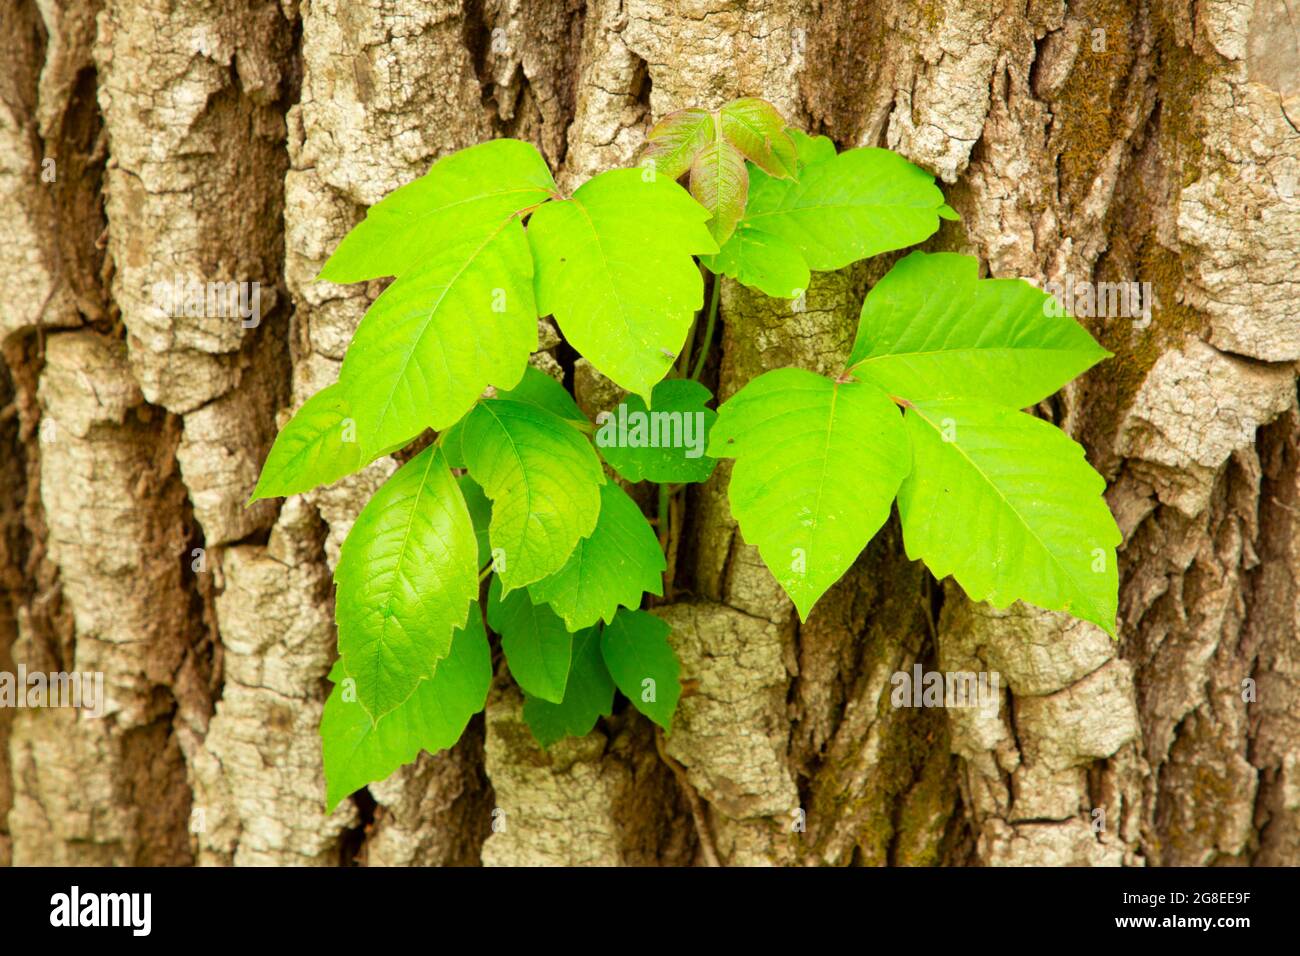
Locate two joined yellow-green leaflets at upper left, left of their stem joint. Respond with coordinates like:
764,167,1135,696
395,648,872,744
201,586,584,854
321,139,555,463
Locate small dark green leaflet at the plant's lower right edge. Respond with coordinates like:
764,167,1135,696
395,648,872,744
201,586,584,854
601,611,681,731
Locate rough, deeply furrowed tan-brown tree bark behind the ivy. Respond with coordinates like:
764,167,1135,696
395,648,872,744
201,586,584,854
0,0,1300,865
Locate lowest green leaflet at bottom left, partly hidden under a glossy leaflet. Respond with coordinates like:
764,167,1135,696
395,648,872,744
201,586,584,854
321,607,491,812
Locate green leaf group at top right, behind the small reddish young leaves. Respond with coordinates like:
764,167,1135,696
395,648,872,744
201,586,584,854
709,143,946,298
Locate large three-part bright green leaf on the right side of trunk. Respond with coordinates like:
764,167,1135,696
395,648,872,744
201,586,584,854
710,252,1119,633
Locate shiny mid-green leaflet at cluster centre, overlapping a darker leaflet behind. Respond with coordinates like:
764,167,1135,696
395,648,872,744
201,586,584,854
462,398,605,592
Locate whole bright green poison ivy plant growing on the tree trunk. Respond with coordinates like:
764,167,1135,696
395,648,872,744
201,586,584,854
254,99,1119,808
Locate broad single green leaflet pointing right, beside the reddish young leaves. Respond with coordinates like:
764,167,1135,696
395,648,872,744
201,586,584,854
744,147,944,272
